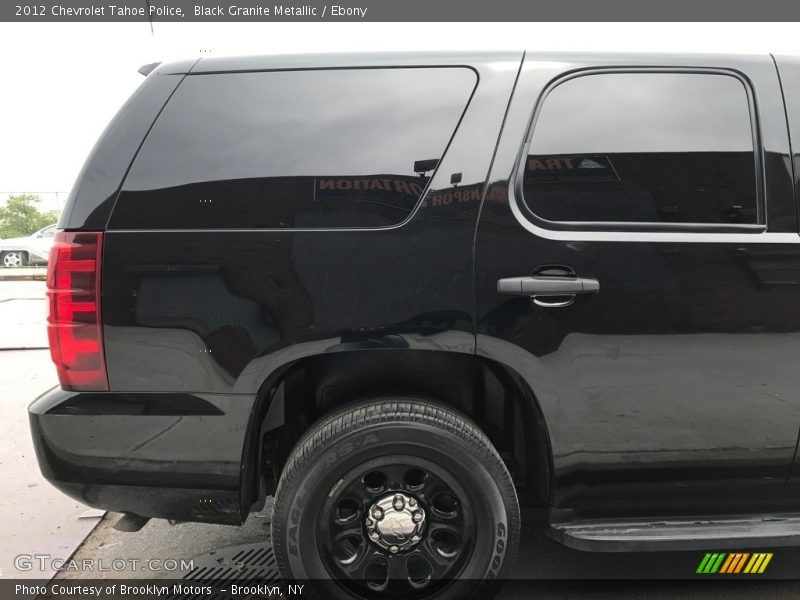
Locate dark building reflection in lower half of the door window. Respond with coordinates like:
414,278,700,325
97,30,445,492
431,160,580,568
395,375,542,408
523,151,758,223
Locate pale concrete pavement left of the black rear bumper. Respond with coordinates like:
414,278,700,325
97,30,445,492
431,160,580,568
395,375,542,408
0,278,103,579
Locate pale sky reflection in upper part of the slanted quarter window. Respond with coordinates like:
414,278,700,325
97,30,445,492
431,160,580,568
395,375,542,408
125,68,476,191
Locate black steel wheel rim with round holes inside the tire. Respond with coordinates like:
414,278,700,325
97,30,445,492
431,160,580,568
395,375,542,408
317,455,477,599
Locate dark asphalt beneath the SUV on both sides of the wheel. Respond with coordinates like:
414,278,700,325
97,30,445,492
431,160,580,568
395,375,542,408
53,504,800,600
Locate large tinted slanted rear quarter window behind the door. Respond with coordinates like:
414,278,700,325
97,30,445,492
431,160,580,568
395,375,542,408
110,68,476,229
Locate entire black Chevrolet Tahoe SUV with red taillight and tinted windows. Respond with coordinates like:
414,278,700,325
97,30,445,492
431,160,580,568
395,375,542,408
30,53,800,598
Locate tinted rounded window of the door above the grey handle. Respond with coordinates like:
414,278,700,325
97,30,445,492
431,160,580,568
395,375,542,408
524,73,758,223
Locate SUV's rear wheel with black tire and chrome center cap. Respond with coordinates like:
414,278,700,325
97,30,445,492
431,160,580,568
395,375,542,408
272,398,520,600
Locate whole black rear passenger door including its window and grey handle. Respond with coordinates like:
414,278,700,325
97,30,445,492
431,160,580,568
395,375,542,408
477,56,800,516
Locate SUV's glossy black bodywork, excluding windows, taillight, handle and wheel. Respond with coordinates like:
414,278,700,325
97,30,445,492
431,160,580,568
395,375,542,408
31,53,800,522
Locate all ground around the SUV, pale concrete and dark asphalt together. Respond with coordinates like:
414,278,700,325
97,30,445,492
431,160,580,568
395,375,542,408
0,281,800,599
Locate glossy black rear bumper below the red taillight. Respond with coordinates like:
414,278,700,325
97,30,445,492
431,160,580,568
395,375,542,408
28,388,255,523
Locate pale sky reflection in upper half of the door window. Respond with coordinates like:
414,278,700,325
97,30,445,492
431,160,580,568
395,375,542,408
530,73,753,154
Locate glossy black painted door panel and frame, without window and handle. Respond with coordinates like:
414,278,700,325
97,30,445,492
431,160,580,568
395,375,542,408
476,52,800,519
